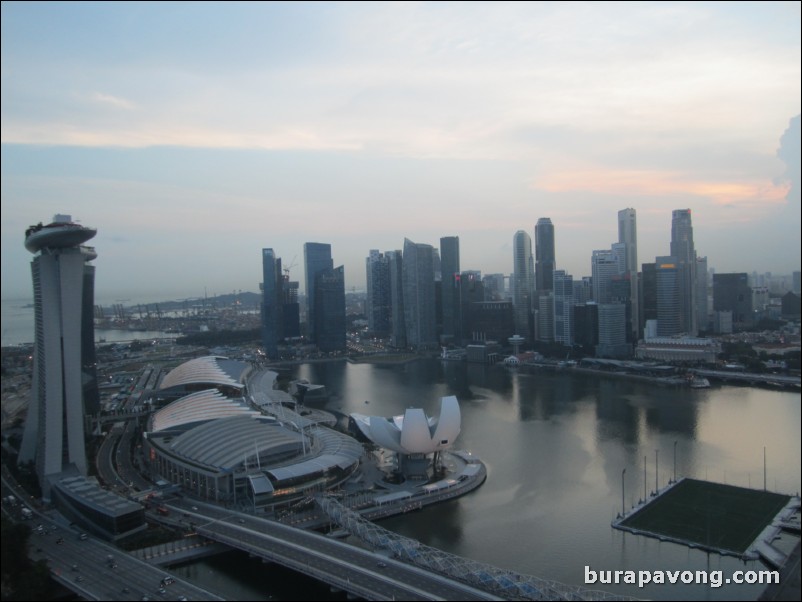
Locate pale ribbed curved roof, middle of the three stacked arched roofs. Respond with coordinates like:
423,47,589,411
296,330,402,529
151,389,261,432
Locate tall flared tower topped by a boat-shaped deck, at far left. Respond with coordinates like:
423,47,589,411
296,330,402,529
19,215,97,499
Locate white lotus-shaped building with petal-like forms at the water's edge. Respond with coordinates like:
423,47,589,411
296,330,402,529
351,395,462,455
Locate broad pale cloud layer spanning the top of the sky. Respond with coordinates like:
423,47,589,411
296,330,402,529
2,3,799,160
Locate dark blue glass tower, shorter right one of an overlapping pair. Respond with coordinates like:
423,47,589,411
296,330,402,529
314,266,345,353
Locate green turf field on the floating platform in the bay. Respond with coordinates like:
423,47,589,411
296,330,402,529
620,479,791,554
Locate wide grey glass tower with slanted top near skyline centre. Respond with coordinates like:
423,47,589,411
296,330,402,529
402,238,438,348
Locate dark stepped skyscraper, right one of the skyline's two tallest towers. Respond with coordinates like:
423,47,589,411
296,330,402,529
658,209,698,337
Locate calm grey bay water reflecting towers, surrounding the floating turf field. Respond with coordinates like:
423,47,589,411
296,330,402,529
172,359,802,600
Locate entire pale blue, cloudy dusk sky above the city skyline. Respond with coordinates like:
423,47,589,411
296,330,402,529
0,1,802,301
